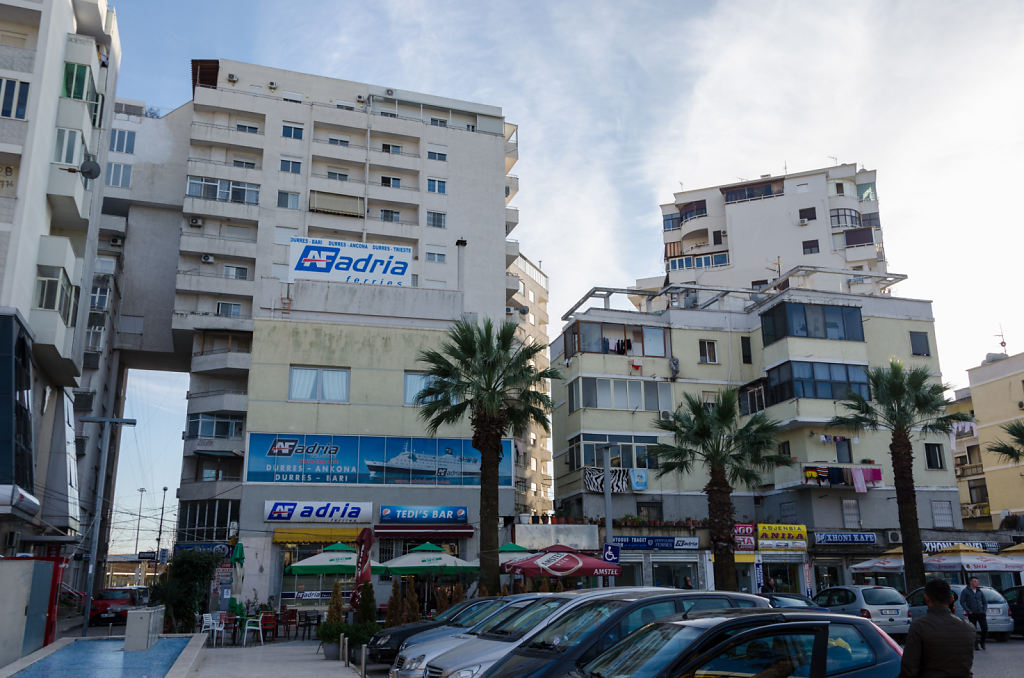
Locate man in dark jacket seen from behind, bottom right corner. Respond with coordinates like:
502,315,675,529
899,579,974,678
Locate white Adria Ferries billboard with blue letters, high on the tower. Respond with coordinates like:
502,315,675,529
288,238,413,287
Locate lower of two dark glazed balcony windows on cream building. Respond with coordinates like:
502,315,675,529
768,361,870,405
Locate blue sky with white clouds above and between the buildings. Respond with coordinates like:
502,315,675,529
105,0,1024,550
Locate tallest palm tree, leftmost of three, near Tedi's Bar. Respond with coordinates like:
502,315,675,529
416,319,560,593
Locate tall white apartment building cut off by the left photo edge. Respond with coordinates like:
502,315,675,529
0,0,121,588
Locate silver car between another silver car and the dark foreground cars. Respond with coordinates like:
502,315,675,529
411,587,666,678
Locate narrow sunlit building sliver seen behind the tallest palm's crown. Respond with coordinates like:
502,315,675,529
505,253,554,516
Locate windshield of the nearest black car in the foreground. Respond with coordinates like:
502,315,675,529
584,624,702,678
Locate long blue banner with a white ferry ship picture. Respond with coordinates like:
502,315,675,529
240,433,512,486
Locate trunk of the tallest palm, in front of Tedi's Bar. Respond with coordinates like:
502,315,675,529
472,416,505,595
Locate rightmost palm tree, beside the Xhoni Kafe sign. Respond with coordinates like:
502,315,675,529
828,358,970,591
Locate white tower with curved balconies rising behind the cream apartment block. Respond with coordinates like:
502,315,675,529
662,164,886,292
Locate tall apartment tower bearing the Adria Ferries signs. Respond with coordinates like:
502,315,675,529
105,59,524,603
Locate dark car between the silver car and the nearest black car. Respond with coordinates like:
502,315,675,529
483,591,768,678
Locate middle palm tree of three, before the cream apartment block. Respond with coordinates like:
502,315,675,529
648,390,791,591
